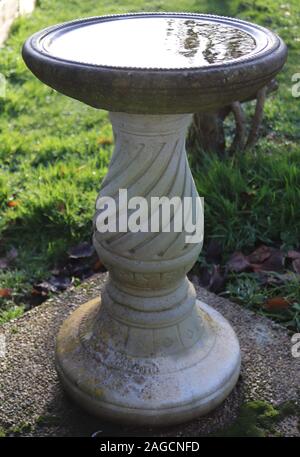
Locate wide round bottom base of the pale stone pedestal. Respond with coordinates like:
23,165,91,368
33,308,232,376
56,299,240,426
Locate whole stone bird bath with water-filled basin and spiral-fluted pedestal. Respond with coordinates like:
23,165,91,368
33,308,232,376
23,13,286,425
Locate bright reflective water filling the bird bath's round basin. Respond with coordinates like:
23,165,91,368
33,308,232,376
43,16,256,68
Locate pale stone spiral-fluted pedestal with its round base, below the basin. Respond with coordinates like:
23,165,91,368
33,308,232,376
56,113,240,425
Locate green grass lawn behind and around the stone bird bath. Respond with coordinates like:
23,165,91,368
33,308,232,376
0,0,300,330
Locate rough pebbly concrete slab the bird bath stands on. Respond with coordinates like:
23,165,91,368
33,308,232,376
0,274,300,436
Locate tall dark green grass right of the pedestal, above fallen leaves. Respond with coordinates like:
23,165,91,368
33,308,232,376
194,146,300,252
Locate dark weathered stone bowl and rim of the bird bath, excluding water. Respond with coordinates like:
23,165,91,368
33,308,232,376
23,13,287,114
